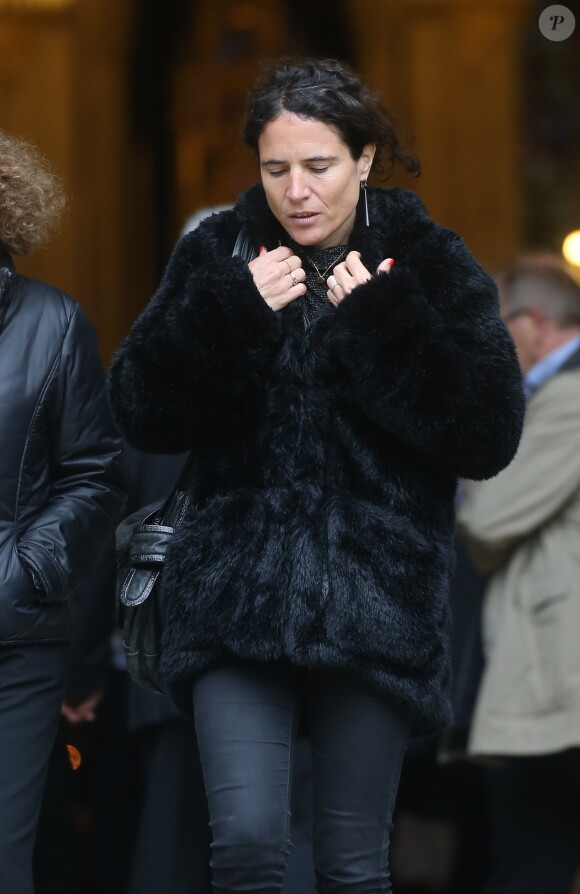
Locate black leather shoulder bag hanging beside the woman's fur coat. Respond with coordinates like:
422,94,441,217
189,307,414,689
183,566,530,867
117,227,257,693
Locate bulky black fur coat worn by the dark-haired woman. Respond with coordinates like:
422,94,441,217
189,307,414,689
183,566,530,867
110,186,524,732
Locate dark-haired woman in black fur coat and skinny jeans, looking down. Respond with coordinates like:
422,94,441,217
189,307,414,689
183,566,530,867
106,60,523,894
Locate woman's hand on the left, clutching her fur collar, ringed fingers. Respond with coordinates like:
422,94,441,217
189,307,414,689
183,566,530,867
248,245,306,310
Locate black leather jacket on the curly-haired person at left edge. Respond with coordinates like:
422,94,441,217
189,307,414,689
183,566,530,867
0,253,125,643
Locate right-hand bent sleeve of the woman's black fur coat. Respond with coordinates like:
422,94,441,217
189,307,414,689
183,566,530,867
331,198,524,479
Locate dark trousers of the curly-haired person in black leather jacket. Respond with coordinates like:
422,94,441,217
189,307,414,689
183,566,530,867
0,643,68,894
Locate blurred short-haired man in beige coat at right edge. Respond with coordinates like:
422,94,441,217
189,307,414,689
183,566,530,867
458,256,580,894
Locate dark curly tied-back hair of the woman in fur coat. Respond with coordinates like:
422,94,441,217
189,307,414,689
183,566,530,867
243,57,421,177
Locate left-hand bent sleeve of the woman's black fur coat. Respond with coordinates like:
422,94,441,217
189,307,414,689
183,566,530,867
110,212,280,453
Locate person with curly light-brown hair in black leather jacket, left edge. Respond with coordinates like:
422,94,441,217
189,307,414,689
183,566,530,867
0,131,125,894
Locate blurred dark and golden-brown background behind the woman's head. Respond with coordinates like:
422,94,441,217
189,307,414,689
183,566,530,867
0,0,580,361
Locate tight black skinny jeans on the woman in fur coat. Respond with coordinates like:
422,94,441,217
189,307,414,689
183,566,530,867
193,665,409,894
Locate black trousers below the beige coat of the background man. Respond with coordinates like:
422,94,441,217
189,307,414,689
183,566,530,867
484,748,580,894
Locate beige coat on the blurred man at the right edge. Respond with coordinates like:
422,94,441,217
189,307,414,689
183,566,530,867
458,368,580,755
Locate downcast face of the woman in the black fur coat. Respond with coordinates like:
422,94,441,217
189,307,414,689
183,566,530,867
258,112,375,248
